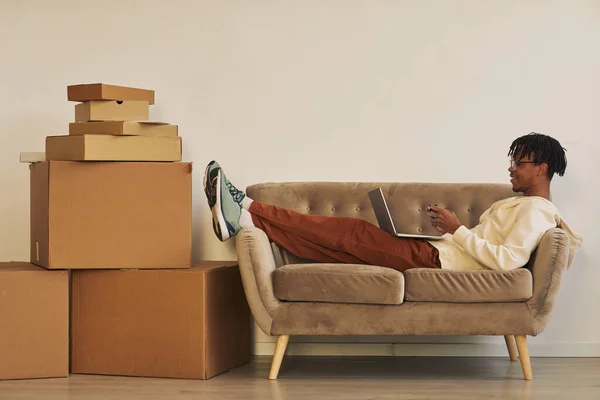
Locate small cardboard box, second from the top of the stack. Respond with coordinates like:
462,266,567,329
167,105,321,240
75,100,150,122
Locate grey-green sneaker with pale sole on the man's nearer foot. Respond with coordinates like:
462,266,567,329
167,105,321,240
204,162,242,242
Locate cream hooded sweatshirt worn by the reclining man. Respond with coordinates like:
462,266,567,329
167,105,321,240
429,196,582,271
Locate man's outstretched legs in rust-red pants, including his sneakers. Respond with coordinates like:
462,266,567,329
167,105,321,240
204,161,440,271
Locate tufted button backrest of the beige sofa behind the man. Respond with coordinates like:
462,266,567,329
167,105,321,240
247,182,516,266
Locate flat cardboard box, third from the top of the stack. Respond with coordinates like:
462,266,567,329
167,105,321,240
69,121,178,137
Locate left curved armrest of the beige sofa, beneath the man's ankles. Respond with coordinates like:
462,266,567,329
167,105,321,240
236,228,280,335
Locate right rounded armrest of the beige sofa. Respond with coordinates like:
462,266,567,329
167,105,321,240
527,228,569,336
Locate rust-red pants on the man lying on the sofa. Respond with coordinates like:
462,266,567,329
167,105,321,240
249,201,441,271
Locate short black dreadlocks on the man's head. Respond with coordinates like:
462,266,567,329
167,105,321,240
508,132,567,180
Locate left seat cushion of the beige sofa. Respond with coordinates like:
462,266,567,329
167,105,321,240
273,263,404,304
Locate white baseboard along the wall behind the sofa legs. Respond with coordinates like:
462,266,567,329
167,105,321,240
254,342,600,357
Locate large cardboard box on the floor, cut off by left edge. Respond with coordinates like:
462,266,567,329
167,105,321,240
0,262,69,380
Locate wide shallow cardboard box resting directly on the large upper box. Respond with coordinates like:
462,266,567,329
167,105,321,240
46,135,181,161
